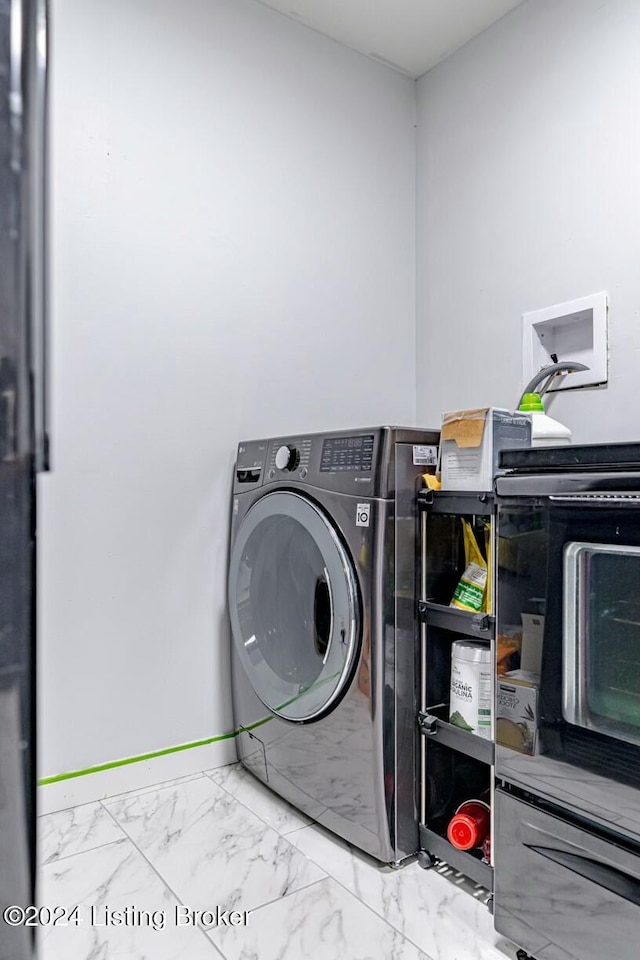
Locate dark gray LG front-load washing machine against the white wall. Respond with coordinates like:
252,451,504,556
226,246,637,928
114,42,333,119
228,427,438,863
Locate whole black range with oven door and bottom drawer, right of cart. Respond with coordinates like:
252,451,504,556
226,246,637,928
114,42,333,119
494,444,640,960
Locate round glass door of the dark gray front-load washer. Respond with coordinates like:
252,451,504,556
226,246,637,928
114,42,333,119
229,491,360,721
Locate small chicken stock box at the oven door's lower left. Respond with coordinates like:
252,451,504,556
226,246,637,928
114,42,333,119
496,670,540,756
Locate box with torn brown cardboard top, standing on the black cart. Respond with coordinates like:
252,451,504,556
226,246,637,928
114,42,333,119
440,407,531,490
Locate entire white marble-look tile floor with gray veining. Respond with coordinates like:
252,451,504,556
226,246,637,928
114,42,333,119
37,764,515,960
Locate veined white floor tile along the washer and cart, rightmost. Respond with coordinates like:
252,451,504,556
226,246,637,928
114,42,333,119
289,826,515,960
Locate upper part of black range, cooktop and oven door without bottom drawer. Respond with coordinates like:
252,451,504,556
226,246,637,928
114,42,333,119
496,444,640,787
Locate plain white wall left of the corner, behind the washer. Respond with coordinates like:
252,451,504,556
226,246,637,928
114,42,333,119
39,0,415,775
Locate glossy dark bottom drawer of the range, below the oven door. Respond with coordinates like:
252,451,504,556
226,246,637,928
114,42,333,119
494,789,640,960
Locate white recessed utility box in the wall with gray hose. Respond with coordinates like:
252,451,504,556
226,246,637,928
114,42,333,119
522,291,608,391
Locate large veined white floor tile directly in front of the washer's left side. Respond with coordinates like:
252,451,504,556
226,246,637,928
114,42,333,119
105,777,325,910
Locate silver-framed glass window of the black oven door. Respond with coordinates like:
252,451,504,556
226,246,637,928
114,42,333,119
563,542,640,744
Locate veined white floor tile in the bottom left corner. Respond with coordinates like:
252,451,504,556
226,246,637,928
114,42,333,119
38,839,220,960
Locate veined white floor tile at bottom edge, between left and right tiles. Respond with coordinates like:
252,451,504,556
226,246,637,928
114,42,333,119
208,878,430,960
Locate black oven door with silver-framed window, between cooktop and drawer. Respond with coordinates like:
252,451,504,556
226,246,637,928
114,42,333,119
497,497,640,786
